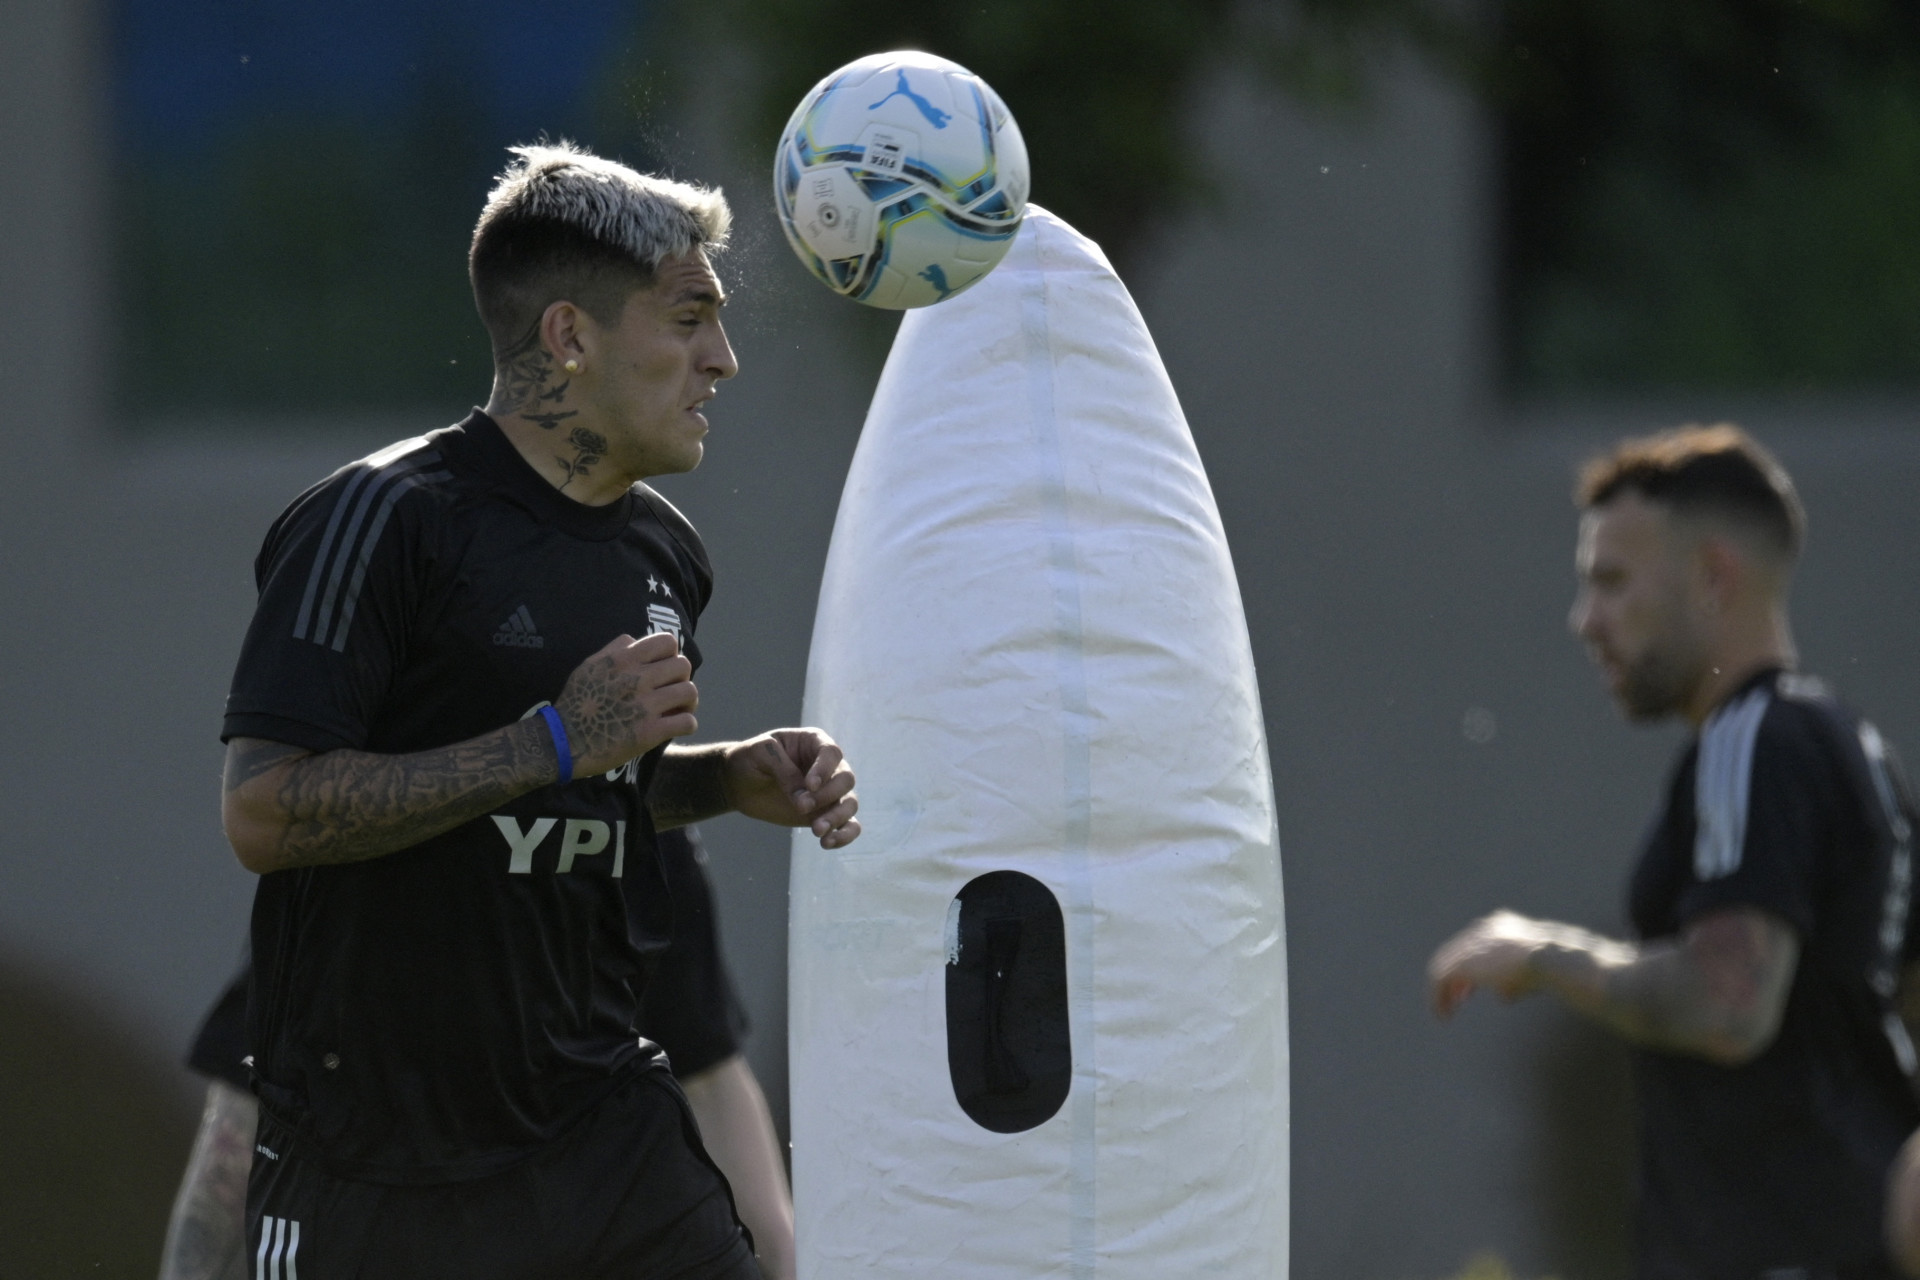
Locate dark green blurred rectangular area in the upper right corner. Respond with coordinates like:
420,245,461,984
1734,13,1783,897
1482,0,1920,391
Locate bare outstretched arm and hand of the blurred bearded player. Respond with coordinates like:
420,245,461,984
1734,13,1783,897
1427,906,1799,1067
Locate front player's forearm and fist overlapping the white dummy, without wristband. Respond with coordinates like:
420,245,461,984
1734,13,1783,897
647,729,860,848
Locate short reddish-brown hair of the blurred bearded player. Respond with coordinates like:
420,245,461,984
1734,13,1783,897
1574,422,1807,570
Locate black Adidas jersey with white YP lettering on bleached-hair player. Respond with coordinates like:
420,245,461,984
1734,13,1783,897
223,411,712,1182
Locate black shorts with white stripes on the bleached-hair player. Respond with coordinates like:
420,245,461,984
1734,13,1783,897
246,1069,760,1280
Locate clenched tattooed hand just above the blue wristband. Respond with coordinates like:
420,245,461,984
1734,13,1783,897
553,631,701,777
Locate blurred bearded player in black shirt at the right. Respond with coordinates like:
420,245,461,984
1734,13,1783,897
1428,426,1920,1280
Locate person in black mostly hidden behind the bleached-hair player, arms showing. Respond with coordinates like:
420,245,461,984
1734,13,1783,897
159,827,795,1280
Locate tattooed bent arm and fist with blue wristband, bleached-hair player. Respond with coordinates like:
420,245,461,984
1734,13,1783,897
221,635,699,873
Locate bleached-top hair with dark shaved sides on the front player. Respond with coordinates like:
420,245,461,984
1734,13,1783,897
467,140,733,357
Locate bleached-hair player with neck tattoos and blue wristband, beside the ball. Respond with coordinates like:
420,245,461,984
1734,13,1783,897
223,144,860,1280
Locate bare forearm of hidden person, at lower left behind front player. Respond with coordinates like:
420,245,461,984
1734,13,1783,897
159,1080,259,1280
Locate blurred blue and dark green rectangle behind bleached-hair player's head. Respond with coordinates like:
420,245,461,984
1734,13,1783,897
108,0,668,428
